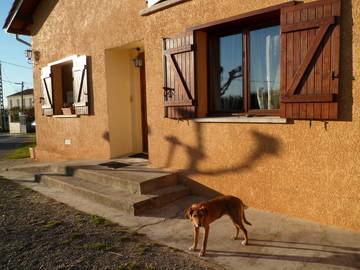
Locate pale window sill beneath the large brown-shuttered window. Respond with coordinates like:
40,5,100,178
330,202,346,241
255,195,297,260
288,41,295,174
193,116,287,124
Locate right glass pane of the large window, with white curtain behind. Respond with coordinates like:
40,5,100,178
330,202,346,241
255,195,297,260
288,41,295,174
250,26,280,110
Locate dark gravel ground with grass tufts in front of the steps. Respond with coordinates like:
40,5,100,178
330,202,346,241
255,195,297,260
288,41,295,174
0,178,224,270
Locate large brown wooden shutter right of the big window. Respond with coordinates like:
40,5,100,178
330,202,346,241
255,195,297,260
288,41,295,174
281,0,341,119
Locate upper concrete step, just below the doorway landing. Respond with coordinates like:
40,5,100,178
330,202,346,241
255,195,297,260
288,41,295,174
67,167,177,194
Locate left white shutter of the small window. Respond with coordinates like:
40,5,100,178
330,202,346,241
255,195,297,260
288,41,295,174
40,66,54,115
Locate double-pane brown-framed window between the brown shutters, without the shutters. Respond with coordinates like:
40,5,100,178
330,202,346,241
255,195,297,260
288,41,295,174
209,25,280,114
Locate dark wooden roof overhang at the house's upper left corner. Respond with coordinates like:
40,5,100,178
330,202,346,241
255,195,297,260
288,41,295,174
3,0,41,36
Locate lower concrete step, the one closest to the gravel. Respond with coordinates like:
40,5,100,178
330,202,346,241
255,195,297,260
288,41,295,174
38,174,189,215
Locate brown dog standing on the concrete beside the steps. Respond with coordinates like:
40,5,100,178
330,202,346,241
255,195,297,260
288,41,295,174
185,196,251,256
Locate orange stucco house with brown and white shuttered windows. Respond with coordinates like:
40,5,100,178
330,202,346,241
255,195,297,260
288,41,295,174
4,0,360,230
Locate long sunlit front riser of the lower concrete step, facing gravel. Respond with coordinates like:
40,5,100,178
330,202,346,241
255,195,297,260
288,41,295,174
40,176,134,215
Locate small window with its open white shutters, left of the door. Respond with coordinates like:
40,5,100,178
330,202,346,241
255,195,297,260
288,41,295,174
41,56,89,115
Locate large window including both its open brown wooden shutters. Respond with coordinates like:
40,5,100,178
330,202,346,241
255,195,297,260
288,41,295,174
163,0,341,119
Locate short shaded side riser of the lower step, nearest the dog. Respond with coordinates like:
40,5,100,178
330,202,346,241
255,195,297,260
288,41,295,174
134,188,190,216
